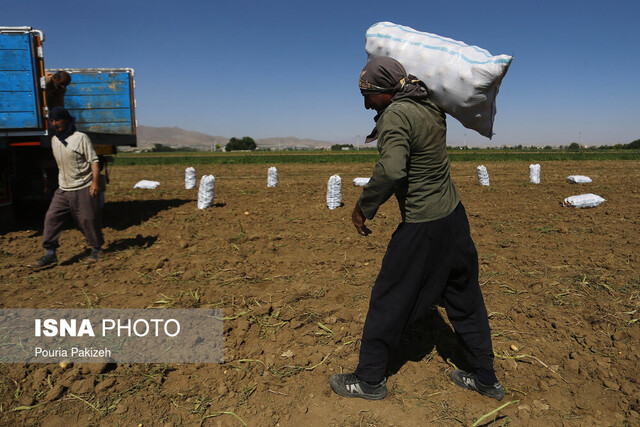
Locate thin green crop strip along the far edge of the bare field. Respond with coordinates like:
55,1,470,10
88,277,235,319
115,149,640,166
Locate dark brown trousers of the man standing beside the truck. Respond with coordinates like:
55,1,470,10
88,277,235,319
42,187,104,249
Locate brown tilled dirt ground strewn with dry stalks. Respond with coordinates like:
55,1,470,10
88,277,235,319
0,161,640,426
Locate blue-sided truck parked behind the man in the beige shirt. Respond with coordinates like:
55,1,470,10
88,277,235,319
0,27,137,231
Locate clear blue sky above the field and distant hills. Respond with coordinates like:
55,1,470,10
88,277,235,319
0,0,640,146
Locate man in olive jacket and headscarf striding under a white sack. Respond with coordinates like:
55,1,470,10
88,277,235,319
329,57,504,400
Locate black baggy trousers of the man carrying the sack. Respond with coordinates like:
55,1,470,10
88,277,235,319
355,203,494,383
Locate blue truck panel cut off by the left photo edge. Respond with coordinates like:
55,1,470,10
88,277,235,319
0,31,43,131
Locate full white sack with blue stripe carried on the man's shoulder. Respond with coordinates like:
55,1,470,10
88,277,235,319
365,22,513,139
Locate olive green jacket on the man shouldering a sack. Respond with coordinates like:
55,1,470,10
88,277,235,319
358,98,460,223
